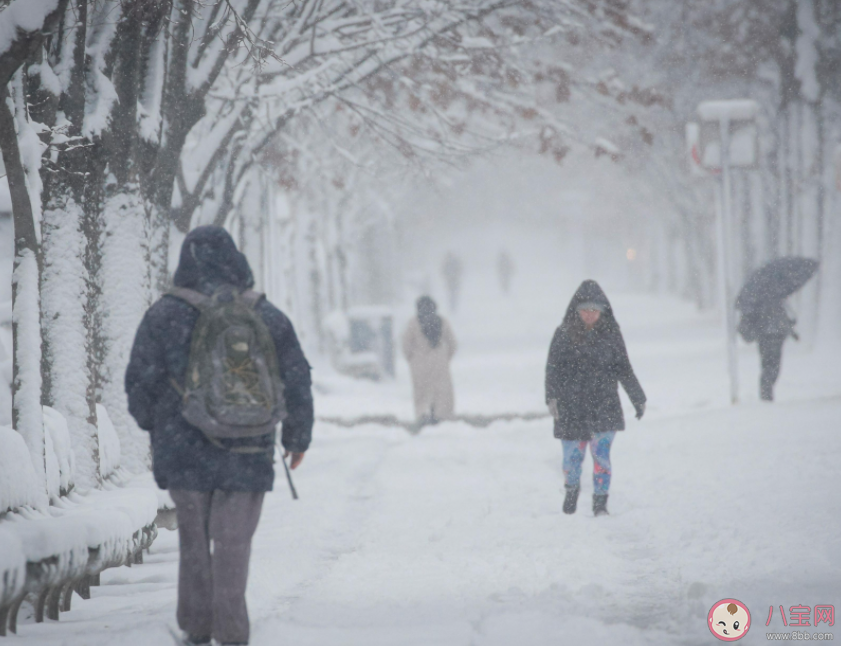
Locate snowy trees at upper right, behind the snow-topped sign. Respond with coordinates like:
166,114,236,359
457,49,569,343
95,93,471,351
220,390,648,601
616,0,841,318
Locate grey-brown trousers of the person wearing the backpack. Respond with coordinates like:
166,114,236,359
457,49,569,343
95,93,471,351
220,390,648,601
169,490,264,644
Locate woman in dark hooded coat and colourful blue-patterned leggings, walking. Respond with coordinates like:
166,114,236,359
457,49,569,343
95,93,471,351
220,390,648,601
546,280,645,516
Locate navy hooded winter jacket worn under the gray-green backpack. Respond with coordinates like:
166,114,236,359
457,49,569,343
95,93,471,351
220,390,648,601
125,227,313,492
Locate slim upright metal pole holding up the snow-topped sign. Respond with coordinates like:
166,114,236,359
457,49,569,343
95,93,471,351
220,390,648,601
718,119,739,404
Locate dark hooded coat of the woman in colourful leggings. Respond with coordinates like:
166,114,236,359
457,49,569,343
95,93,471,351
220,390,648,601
546,280,645,440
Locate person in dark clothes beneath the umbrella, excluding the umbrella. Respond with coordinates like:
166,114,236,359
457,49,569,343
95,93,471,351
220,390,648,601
739,300,799,401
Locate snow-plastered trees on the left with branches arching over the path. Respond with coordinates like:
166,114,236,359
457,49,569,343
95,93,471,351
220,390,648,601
0,0,650,496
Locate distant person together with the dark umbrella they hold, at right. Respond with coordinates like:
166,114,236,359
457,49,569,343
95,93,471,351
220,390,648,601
736,257,818,401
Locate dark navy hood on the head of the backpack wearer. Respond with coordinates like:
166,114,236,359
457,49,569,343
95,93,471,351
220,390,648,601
173,226,254,294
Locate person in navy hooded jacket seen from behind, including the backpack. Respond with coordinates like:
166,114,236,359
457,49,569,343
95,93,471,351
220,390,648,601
125,226,313,645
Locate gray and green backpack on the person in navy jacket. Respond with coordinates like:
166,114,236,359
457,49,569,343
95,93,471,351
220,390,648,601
169,287,286,453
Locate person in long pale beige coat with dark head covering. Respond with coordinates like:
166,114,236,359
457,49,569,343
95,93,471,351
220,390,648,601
403,296,456,425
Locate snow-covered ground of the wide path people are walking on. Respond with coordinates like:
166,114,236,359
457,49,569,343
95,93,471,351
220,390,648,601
10,274,841,646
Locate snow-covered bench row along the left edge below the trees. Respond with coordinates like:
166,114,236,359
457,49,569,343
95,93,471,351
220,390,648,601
0,410,159,636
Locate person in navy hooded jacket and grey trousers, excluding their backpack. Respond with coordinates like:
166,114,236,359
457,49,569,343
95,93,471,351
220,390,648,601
125,226,313,644
